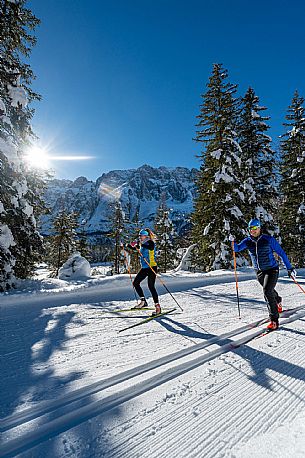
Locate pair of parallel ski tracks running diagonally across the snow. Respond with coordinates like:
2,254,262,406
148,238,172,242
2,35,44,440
1,306,305,458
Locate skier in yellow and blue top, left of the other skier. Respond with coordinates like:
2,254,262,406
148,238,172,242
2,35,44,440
127,228,161,315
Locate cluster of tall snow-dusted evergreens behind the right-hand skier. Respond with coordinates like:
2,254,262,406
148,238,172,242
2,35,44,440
192,64,305,271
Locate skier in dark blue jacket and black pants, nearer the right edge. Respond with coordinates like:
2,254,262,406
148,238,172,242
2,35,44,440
229,218,296,331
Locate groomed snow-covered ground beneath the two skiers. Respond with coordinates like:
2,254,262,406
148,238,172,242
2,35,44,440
0,270,305,458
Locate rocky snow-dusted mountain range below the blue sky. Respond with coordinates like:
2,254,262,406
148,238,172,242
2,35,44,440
41,165,198,236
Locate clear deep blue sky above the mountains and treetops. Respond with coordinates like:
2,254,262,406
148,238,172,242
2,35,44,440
27,0,305,180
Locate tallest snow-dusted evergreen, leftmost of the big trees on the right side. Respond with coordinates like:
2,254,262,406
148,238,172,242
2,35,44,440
192,64,246,271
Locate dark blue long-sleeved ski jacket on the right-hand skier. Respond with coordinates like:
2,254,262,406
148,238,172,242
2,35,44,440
234,234,292,270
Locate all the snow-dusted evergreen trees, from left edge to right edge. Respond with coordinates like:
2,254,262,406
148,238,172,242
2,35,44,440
0,0,305,291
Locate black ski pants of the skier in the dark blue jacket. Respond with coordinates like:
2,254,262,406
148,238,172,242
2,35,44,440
256,269,282,321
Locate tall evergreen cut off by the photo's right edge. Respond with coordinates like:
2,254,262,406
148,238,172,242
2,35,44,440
279,91,305,267
